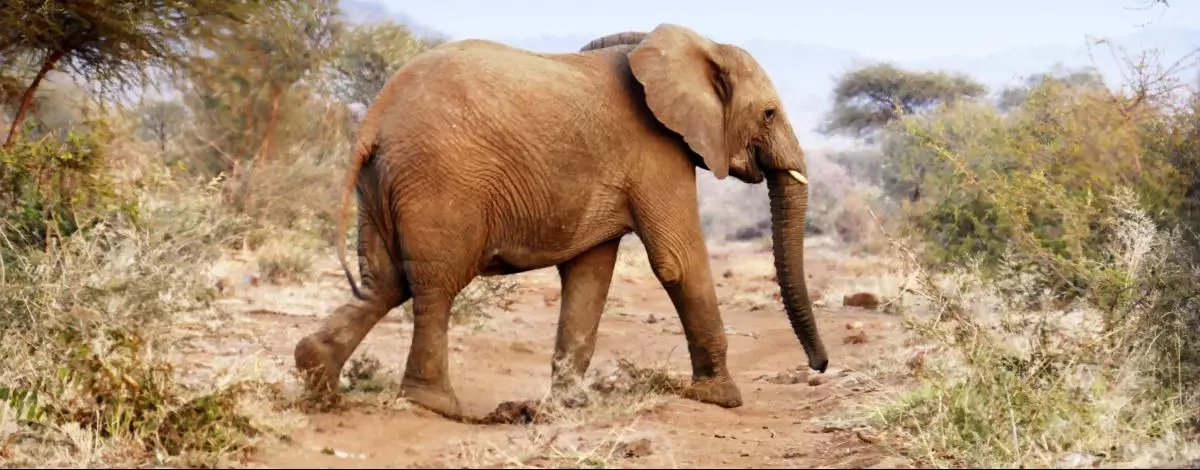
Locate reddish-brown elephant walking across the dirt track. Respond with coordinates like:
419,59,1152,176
294,23,829,418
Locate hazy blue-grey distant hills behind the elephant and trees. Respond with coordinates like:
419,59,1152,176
342,0,1200,144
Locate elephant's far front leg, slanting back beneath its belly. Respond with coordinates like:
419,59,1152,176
551,239,620,406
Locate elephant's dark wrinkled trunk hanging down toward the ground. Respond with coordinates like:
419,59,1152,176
767,171,829,372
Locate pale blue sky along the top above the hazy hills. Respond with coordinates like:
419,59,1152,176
377,0,1200,60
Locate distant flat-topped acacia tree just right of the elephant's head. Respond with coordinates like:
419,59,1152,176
822,64,986,138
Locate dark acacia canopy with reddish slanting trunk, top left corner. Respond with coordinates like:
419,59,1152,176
0,0,256,150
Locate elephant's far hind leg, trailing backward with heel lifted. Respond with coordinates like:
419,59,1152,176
295,216,410,399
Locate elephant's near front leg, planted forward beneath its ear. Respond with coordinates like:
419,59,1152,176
636,194,742,408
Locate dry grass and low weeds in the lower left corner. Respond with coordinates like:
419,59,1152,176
0,173,307,466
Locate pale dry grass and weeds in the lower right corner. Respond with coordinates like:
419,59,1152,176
866,193,1196,468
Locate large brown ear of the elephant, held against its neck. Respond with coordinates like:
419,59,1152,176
629,24,733,179
